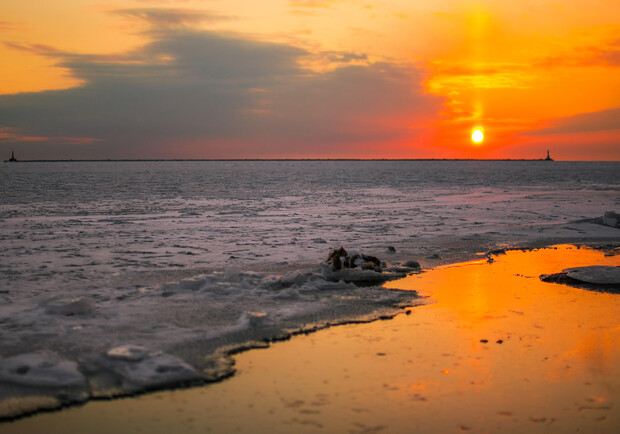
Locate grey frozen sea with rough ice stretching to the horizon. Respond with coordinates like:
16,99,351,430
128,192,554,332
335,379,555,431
0,161,620,417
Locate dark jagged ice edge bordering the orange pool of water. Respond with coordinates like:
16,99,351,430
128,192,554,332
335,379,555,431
0,239,620,423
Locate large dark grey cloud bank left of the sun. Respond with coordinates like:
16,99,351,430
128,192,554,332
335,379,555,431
0,18,443,158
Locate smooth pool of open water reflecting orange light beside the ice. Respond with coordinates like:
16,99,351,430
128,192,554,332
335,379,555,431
2,246,620,434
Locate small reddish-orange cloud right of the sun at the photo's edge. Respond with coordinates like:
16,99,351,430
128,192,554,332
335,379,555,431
529,107,620,135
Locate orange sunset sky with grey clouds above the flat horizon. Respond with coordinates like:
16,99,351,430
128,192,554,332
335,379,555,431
0,0,620,160
